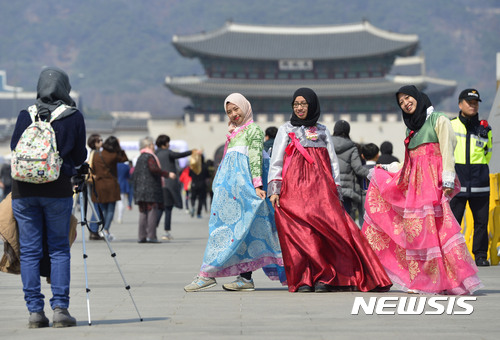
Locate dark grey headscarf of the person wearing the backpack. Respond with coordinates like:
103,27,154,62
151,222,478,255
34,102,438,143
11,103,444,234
36,67,76,117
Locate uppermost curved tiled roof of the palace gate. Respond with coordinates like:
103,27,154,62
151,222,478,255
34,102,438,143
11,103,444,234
172,21,418,60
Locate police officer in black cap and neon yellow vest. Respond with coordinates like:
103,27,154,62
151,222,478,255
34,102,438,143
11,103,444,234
450,89,492,266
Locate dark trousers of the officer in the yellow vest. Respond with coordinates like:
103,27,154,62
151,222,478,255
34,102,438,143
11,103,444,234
450,196,490,260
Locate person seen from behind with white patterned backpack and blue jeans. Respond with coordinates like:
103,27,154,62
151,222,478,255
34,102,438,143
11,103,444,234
10,67,87,328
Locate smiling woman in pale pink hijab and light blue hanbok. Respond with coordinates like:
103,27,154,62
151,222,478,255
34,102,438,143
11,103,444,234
184,93,285,292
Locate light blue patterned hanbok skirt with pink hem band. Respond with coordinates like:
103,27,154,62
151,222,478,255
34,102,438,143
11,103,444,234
200,148,286,283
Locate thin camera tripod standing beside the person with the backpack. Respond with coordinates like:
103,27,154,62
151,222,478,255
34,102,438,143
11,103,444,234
72,175,143,326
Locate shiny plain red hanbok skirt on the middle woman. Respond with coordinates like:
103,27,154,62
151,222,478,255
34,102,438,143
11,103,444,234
275,148,392,292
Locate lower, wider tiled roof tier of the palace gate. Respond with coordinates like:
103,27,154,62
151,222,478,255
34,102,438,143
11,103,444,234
165,76,456,99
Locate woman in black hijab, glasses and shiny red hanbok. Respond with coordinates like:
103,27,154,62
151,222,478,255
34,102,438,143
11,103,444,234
268,88,391,292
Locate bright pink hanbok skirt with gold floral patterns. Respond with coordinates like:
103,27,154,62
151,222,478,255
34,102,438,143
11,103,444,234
362,143,483,295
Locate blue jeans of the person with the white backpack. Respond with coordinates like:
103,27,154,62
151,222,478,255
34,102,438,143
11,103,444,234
12,197,73,312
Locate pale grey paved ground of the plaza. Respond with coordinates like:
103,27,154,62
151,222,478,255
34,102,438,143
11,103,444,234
0,206,500,340
